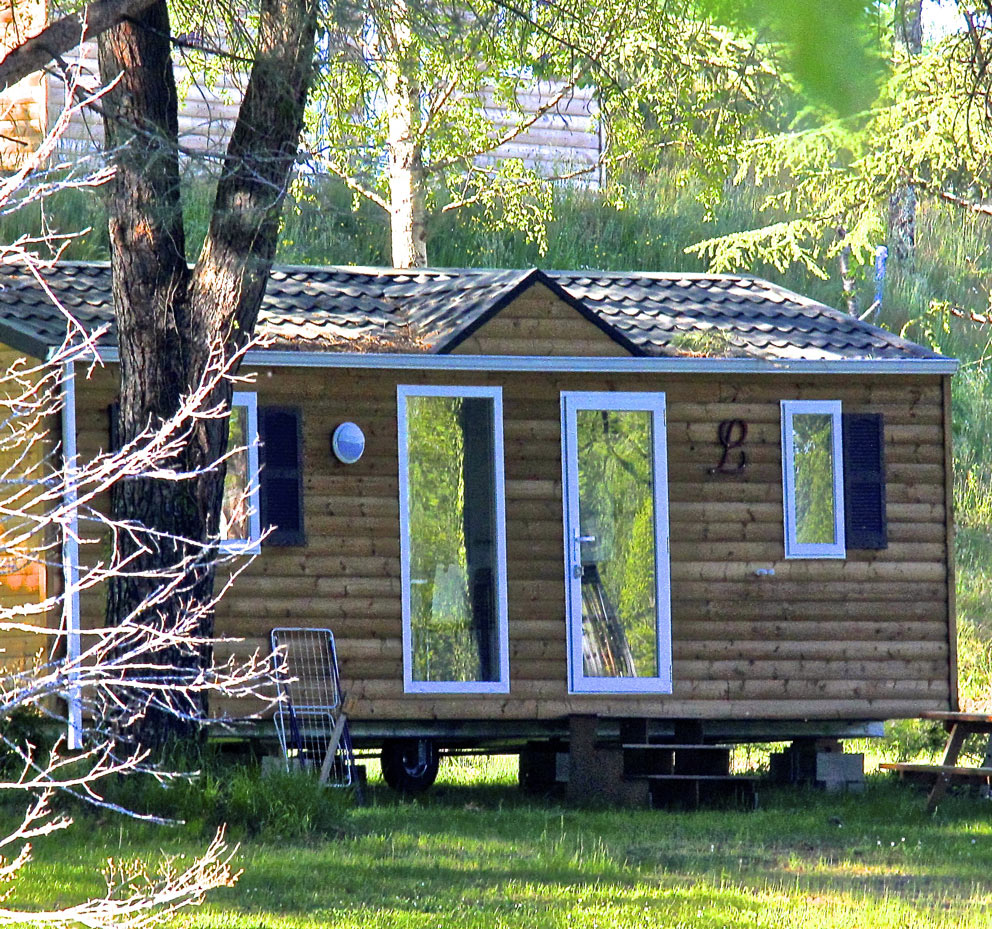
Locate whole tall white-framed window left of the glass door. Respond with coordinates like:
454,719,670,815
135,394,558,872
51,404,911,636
397,387,509,693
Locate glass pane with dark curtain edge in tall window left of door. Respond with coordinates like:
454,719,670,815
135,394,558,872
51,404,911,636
406,396,500,682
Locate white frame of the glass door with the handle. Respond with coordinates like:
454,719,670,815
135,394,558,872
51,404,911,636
561,391,672,694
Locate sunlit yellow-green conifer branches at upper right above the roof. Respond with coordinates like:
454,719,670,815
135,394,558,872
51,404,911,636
689,4,992,300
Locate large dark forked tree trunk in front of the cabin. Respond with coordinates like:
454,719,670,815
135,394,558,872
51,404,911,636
100,0,316,747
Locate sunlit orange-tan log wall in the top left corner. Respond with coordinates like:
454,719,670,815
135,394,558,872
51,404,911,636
0,0,48,171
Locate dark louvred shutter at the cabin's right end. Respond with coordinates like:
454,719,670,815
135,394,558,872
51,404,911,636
843,413,889,548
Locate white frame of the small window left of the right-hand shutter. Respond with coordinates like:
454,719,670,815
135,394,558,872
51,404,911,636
781,400,847,558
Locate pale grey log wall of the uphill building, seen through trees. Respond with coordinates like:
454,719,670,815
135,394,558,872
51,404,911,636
29,36,603,187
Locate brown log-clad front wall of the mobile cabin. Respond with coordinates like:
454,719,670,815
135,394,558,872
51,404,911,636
68,348,951,720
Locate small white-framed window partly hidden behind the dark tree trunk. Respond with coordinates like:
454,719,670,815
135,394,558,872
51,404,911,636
219,392,262,554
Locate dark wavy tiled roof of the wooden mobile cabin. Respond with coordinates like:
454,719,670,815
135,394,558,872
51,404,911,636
0,262,940,361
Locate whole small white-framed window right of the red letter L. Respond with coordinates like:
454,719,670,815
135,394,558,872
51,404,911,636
782,400,845,558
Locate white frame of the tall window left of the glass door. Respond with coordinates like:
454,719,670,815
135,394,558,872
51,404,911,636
396,384,510,694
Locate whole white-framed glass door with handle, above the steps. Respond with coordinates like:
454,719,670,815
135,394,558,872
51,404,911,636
562,392,672,693
